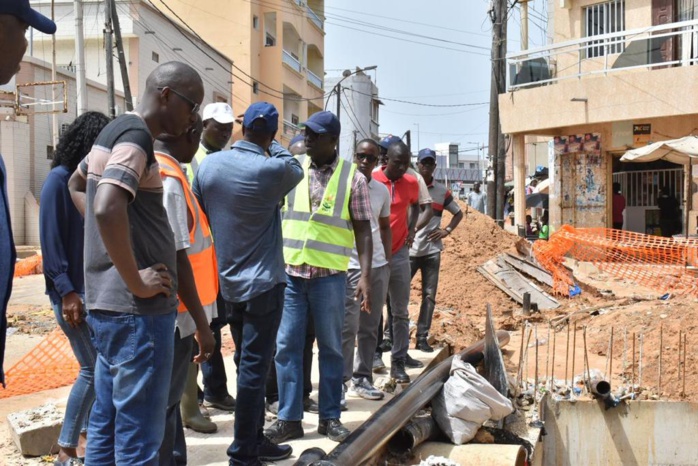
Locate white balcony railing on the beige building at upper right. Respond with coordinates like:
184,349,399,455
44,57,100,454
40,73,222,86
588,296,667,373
507,20,698,91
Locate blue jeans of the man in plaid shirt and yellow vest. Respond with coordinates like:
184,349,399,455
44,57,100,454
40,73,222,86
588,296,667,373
276,273,347,421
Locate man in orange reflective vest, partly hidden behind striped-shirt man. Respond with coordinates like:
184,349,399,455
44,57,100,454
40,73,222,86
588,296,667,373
154,115,218,466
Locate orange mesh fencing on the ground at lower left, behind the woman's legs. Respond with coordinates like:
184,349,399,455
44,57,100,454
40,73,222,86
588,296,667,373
0,328,80,398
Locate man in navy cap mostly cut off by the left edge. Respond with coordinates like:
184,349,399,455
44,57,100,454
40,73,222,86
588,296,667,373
0,0,56,387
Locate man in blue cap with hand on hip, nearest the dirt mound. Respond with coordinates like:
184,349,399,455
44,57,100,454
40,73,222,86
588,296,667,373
410,149,463,353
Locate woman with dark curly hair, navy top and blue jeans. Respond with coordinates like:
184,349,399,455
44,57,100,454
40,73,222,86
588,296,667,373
39,112,109,466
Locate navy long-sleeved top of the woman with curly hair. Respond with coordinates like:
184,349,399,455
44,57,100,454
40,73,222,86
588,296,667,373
39,165,85,303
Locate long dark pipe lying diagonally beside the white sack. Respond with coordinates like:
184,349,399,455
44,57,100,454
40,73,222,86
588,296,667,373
300,330,509,466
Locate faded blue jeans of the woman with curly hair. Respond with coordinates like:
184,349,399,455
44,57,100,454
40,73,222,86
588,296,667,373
51,295,97,448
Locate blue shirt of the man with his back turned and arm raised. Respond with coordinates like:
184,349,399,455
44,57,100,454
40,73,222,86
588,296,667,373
193,141,303,303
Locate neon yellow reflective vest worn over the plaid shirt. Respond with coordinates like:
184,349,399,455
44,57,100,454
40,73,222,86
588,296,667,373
282,155,356,271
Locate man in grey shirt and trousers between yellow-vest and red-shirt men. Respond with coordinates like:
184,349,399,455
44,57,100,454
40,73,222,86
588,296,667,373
342,139,392,405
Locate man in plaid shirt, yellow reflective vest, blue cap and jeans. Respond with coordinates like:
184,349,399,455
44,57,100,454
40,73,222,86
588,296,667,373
266,112,373,443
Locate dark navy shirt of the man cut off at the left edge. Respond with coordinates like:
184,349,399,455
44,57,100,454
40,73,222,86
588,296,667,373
0,155,17,387
